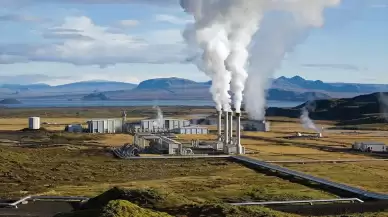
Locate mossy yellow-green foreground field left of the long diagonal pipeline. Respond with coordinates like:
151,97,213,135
0,146,334,202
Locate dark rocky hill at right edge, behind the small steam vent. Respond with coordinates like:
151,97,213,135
266,93,388,124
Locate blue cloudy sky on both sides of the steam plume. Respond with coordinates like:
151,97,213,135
0,0,388,84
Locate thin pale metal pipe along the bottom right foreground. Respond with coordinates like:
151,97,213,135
230,198,364,206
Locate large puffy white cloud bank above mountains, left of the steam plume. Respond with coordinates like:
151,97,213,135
0,16,186,67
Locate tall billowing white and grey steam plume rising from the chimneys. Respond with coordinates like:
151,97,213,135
181,0,340,119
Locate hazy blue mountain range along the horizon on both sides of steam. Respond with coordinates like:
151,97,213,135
0,76,388,101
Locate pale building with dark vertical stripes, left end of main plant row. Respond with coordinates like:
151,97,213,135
87,118,123,133
